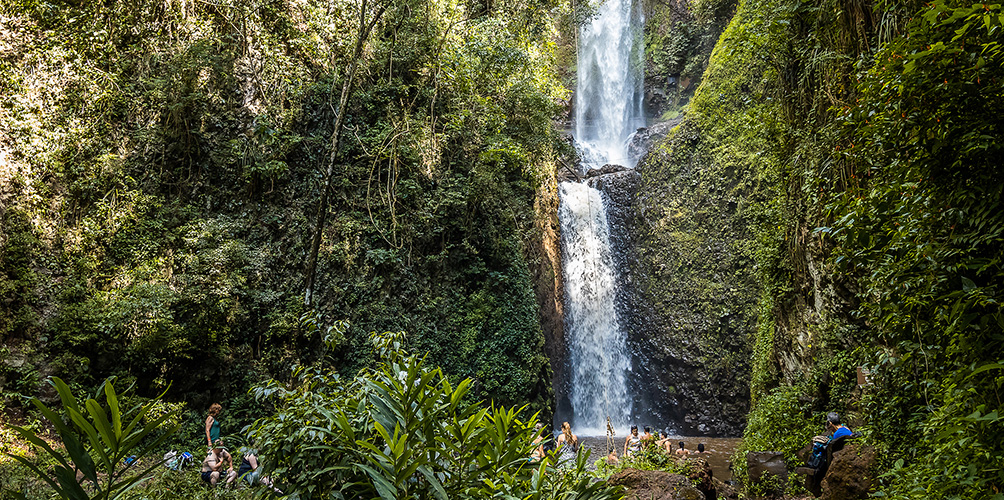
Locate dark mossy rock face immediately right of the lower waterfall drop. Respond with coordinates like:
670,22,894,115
611,119,756,435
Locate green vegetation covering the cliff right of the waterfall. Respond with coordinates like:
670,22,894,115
643,0,1004,499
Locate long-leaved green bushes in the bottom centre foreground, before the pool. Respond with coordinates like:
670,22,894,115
251,332,619,500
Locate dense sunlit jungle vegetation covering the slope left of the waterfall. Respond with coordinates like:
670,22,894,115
0,0,570,434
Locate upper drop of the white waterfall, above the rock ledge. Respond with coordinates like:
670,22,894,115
574,0,645,167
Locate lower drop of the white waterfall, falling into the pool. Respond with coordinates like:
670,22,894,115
558,183,631,436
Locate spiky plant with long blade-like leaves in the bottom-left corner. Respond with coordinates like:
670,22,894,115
10,379,178,500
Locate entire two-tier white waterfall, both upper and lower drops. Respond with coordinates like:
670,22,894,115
556,0,645,436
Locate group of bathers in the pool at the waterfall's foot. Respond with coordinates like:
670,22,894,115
530,422,711,464
